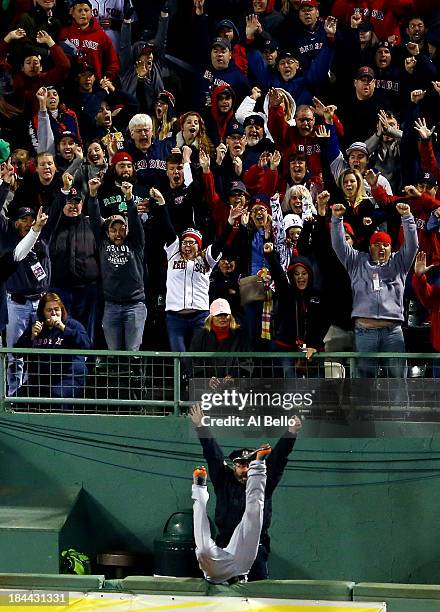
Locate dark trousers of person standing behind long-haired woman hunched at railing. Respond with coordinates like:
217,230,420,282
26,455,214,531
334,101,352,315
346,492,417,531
51,284,98,346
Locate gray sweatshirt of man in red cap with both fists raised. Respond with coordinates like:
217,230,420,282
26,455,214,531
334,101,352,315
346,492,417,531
331,214,419,323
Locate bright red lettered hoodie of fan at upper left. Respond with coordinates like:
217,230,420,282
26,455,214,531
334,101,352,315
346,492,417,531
59,17,119,81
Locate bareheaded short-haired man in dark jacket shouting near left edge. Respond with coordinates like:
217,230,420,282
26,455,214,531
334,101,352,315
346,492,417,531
8,151,62,217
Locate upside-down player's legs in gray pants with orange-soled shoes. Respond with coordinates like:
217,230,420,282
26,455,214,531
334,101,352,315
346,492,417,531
192,444,272,584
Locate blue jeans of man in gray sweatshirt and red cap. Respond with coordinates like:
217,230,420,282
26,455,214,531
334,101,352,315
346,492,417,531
354,325,407,378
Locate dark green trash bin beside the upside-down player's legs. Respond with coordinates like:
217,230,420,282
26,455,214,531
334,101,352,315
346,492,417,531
154,510,202,578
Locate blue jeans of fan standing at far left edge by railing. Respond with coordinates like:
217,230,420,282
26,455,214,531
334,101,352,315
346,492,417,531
6,293,39,395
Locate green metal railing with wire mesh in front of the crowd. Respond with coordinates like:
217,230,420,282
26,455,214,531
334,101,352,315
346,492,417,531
0,348,440,416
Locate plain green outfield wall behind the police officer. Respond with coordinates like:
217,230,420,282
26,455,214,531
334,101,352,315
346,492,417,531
0,413,440,583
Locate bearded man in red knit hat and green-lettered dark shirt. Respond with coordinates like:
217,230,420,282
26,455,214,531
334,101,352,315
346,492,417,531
93,151,148,218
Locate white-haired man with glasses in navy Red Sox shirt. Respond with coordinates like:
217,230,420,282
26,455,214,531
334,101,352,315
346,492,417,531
126,113,173,188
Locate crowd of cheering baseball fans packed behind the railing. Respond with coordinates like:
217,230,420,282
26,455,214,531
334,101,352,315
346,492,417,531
0,0,440,393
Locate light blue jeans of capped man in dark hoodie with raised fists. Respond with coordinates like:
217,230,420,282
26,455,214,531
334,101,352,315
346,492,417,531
102,302,147,351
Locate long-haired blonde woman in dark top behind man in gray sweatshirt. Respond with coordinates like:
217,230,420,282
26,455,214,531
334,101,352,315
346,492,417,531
338,168,381,251
